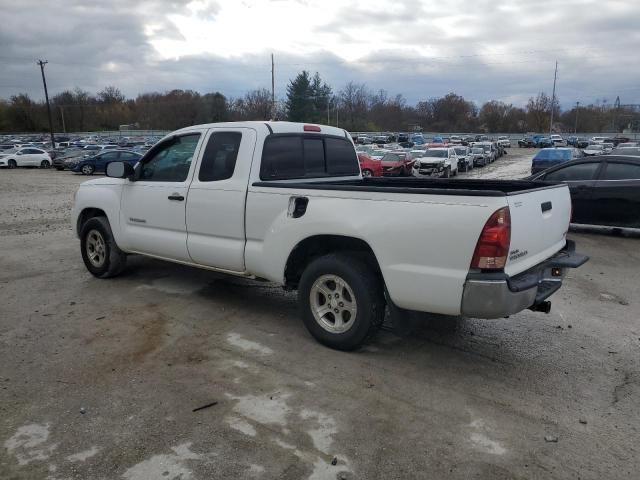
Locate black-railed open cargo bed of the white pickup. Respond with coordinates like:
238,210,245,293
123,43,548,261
253,177,562,197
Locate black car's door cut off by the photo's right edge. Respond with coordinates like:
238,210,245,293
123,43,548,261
591,160,640,228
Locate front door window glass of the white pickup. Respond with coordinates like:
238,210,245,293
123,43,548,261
139,133,200,182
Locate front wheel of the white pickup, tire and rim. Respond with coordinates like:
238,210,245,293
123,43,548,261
80,217,127,278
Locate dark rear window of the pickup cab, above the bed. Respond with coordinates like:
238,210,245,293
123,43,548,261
260,134,360,180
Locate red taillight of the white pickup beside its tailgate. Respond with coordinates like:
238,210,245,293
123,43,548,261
471,207,511,270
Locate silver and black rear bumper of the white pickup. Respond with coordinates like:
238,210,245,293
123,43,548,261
462,240,589,318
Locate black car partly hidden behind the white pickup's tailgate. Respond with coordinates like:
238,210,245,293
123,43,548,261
529,155,640,228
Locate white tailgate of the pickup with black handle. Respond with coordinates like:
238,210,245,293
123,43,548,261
504,185,571,276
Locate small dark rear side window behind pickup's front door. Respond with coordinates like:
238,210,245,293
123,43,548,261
198,132,242,182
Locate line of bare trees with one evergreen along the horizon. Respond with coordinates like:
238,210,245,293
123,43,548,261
0,70,637,133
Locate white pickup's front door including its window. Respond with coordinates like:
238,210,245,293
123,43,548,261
120,132,201,261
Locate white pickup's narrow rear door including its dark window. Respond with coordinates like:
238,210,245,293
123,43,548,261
186,128,257,272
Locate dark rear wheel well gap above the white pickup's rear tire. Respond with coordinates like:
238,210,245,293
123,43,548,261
284,235,382,289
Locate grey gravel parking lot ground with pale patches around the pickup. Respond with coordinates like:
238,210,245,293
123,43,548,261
0,152,640,480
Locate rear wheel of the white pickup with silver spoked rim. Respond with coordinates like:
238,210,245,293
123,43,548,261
298,253,385,351
